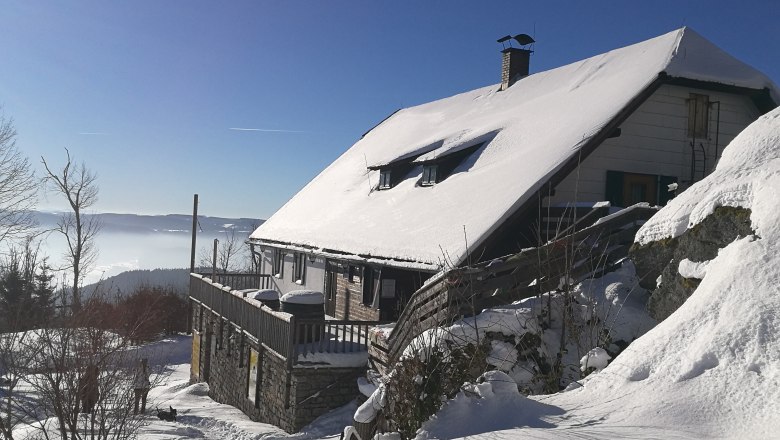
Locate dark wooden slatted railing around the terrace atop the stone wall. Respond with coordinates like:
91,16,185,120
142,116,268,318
190,274,376,368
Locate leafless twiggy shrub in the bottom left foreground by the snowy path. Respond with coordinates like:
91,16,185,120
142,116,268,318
25,295,155,440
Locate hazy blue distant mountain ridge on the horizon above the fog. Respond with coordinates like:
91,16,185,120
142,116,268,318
35,211,265,235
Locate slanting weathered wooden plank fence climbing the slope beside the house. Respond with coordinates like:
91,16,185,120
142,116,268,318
380,205,657,366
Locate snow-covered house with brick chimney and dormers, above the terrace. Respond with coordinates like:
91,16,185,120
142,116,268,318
250,28,780,320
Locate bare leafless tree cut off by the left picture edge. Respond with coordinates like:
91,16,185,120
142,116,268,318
0,108,37,242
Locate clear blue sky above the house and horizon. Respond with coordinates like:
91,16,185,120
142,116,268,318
0,0,780,218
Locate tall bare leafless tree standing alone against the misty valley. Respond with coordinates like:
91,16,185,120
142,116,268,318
41,148,100,311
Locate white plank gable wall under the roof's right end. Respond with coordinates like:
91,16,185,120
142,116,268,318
548,85,759,204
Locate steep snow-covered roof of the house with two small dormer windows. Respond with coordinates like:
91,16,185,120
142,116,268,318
250,28,778,270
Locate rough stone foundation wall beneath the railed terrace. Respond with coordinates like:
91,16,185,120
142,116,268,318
191,304,366,433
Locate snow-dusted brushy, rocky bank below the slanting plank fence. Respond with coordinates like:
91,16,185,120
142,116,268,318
372,262,656,438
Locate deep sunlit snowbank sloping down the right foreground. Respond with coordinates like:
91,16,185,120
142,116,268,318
412,105,780,440
